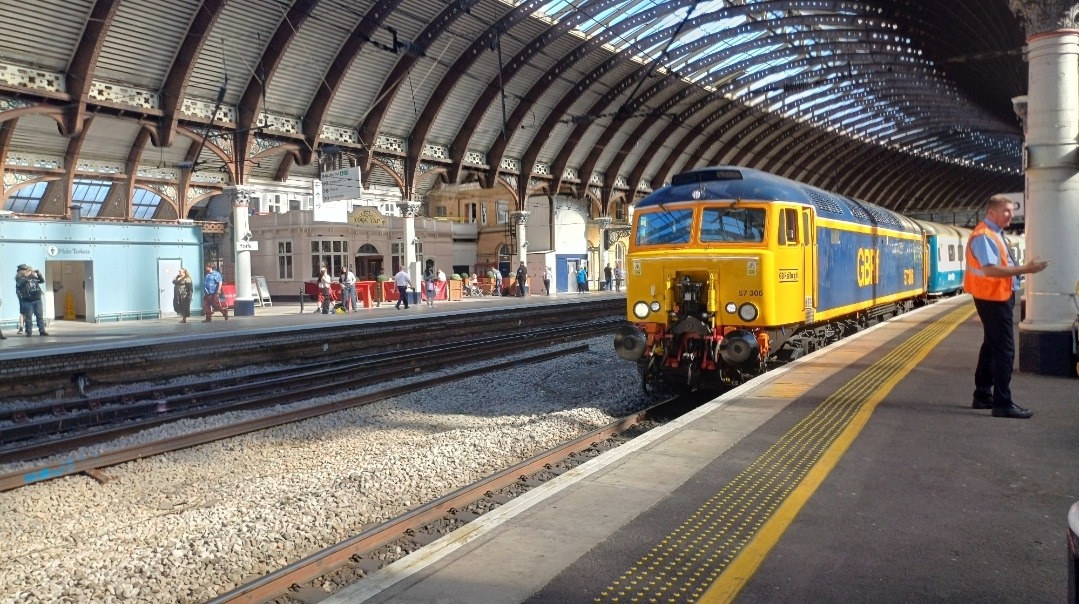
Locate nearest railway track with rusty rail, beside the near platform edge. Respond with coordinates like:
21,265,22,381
207,395,708,604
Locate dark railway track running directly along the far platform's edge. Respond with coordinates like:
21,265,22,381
0,299,626,402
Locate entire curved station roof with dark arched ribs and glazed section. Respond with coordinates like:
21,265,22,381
0,0,1026,219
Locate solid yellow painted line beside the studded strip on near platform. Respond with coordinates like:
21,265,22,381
698,304,974,604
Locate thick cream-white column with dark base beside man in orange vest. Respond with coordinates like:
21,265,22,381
1012,0,1079,376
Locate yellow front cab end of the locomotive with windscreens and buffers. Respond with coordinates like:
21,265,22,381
615,168,809,390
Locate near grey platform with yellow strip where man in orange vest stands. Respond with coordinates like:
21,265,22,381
323,296,1079,604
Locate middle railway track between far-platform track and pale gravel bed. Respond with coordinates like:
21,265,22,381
0,320,618,491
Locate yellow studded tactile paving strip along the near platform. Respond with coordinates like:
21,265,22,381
595,305,973,603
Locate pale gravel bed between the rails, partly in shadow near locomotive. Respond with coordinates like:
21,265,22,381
0,337,650,603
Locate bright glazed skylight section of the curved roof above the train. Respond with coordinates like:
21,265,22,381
528,0,1015,168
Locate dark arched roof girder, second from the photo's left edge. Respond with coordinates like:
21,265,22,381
156,0,226,146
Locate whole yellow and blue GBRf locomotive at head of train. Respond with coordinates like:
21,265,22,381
615,166,926,390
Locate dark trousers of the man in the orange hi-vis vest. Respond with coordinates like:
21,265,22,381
974,293,1015,407
